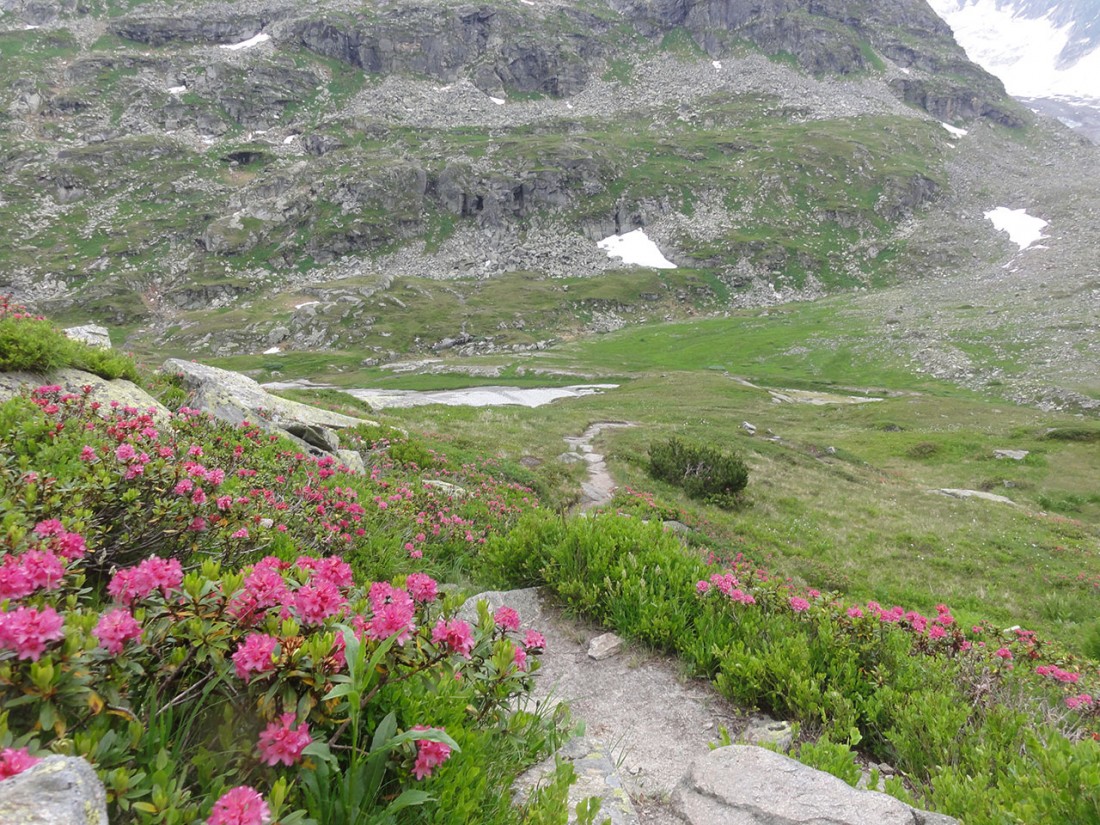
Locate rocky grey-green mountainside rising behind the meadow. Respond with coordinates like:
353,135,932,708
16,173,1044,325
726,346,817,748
0,0,1093,411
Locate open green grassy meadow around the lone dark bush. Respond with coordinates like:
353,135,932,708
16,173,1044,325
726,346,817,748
277,301,1100,657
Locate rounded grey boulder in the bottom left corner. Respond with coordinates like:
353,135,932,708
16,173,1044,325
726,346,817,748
0,756,107,825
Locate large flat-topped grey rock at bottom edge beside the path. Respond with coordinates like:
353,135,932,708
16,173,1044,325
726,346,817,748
672,745,957,825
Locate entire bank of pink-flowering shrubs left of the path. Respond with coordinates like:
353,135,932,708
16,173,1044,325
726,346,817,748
0,386,557,825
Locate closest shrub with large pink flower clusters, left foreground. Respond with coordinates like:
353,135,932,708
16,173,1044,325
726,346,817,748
0,526,545,823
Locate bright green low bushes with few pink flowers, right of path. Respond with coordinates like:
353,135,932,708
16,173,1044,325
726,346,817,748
482,513,1100,825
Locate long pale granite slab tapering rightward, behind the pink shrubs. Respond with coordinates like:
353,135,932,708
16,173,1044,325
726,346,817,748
161,359,376,435
